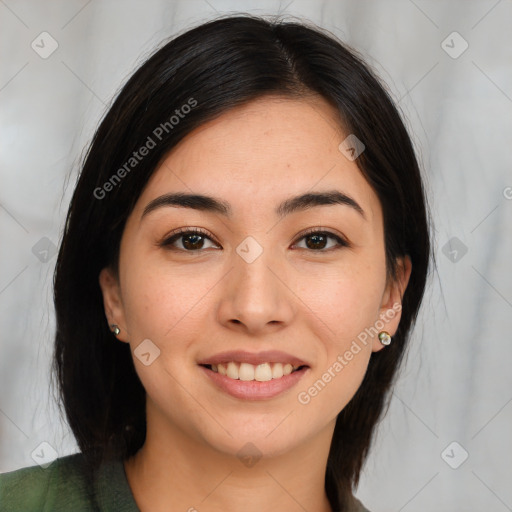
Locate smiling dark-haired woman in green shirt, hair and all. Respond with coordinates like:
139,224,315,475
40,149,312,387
0,12,431,512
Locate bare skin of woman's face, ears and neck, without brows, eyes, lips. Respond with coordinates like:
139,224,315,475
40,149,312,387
99,96,411,512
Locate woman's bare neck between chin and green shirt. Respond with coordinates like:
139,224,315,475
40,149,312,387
125,400,334,512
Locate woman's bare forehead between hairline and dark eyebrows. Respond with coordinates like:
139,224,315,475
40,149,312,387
138,97,380,221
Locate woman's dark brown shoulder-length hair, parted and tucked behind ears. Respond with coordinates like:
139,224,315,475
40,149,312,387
53,15,432,510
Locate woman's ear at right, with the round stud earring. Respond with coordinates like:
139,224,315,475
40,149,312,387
372,255,412,352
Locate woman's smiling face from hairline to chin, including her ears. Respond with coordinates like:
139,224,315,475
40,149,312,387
100,97,411,455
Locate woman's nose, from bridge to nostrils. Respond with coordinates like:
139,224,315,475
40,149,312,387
218,245,295,335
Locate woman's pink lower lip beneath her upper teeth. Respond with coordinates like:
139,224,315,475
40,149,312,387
200,366,309,400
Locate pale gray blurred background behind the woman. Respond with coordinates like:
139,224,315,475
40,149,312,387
0,0,512,512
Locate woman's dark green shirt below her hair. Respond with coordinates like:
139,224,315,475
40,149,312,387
0,453,369,512
